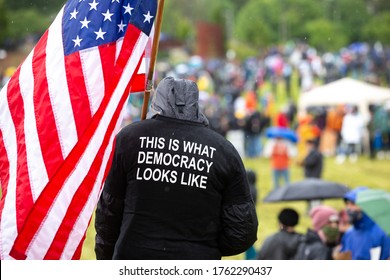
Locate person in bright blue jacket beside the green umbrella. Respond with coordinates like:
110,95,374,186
334,187,390,260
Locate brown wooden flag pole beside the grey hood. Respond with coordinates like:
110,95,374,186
141,0,164,120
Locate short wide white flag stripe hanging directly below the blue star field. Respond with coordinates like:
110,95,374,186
80,47,105,116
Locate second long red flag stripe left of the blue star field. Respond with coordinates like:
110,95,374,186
7,67,33,231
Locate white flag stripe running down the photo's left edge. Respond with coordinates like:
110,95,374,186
0,83,17,260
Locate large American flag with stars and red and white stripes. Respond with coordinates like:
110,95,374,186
0,0,157,259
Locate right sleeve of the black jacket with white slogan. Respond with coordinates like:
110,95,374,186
219,150,258,256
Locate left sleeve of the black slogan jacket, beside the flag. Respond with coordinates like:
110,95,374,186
95,137,126,260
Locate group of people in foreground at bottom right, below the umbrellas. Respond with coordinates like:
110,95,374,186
256,187,390,260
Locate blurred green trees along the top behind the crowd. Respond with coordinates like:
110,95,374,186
0,0,390,53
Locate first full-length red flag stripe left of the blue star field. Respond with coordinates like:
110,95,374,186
32,31,64,179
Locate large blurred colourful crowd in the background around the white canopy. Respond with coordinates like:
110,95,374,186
121,43,390,163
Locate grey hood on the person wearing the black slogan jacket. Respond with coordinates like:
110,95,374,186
146,77,209,126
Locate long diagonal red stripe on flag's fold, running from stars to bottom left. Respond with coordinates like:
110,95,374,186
10,25,145,258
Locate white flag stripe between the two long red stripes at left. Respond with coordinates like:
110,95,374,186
19,52,49,201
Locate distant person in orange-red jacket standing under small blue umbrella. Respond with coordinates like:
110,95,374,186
264,138,297,189
